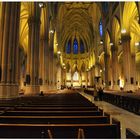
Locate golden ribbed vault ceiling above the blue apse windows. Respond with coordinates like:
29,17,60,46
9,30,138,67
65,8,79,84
57,2,100,50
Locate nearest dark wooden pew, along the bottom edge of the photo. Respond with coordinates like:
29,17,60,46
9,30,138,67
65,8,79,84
0,124,120,139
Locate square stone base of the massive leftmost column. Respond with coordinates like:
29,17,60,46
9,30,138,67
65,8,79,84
0,84,19,99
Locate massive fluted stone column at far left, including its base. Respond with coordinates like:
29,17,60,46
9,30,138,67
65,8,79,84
0,2,20,98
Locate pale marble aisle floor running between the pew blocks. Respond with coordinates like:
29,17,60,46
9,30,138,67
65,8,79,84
80,92,140,139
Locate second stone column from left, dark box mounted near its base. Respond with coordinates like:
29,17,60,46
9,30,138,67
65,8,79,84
25,2,40,94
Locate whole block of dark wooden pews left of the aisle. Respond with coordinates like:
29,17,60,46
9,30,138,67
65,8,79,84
0,93,121,139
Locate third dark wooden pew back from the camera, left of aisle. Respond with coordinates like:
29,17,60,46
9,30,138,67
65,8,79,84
1,110,103,116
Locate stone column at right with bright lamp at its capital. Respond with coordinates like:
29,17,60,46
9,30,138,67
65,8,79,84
122,35,133,90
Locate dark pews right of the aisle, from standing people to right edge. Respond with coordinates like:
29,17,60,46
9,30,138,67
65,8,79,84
103,92,140,115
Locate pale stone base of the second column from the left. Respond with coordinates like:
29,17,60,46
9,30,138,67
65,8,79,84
25,85,40,95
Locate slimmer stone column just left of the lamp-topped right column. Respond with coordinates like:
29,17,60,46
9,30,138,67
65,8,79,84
111,46,120,90
